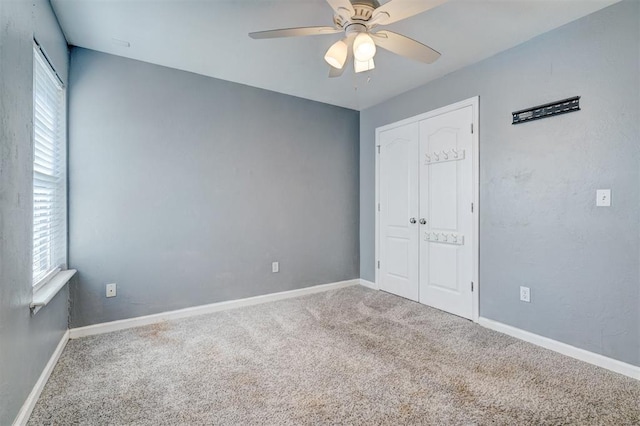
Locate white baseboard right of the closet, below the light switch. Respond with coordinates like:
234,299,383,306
478,317,640,380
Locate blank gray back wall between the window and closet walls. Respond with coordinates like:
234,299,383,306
69,48,359,326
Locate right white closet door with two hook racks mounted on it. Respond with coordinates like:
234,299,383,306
419,106,473,318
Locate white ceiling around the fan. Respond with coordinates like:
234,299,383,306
52,0,619,110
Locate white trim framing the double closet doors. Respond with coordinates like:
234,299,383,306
374,96,480,322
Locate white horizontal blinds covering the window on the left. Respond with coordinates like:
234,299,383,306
33,46,67,287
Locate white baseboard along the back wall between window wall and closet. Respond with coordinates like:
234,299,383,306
69,279,360,339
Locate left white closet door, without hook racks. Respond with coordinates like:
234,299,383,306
378,122,419,301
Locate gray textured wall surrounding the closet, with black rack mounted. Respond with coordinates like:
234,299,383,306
360,1,640,365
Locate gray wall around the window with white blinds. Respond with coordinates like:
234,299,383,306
0,0,69,425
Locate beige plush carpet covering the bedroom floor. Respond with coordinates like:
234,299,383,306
29,286,640,425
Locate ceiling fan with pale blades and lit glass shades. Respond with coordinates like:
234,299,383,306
249,0,447,77
